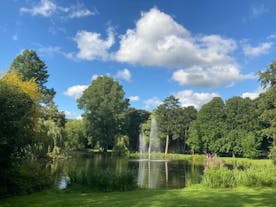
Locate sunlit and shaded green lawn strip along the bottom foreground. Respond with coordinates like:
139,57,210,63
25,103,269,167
0,185,276,207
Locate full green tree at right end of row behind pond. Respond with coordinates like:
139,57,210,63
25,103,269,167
222,97,260,157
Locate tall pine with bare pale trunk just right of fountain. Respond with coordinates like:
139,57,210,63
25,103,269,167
156,96,180,156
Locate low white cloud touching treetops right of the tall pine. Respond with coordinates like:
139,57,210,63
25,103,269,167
174,90,219,109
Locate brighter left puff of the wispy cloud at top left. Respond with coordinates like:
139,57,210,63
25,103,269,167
20,0,57,17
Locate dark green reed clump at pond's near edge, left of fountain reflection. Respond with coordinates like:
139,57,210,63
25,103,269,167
68,170,137,192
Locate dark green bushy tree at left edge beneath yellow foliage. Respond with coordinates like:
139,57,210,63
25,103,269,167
0,80,37,169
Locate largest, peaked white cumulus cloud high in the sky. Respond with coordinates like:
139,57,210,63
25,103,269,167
114,8,236,68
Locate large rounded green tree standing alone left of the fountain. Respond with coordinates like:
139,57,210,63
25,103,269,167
78,76,128,151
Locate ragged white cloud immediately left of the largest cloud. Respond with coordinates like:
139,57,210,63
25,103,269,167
75,29,115,60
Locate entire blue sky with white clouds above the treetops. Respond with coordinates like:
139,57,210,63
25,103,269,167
0,0,276,118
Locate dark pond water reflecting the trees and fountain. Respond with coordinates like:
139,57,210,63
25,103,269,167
50,154,204,189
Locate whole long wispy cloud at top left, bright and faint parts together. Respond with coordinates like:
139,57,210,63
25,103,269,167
20,0,96,18
